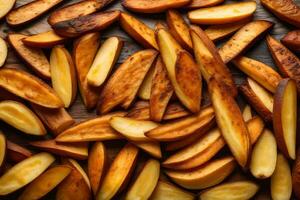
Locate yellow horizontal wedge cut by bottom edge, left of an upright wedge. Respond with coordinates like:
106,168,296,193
200,181,259,200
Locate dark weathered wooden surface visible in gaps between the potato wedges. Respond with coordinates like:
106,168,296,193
0,0,300,199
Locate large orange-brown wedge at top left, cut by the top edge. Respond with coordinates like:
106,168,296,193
6,0,63,26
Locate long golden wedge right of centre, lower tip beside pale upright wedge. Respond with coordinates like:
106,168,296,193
208,77,251,168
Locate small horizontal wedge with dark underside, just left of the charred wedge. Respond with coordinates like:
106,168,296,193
22,30,66,48
